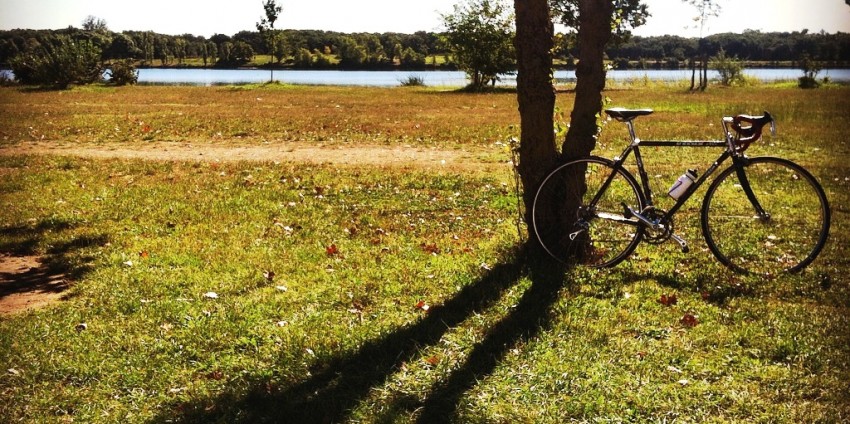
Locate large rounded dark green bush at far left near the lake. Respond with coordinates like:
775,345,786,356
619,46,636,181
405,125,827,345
11,36,104,88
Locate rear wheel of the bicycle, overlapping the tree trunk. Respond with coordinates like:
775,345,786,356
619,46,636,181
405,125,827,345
532,156,645,268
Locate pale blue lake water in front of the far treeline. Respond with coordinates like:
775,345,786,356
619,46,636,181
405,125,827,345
0,68,850,87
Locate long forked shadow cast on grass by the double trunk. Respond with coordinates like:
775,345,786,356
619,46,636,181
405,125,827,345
154,243,564,423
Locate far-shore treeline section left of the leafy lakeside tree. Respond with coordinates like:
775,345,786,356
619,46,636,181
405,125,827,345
0,27,451,68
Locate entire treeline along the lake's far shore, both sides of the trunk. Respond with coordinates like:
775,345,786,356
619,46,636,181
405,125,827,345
0,27,850,69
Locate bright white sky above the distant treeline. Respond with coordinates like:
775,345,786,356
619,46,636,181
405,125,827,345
0,0,850,37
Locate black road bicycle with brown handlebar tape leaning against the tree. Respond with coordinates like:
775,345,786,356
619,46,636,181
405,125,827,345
532,108,830,275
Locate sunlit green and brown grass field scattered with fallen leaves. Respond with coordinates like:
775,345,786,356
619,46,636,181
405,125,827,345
0,86,850,423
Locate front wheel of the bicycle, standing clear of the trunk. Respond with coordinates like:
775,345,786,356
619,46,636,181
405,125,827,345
701,157,830,275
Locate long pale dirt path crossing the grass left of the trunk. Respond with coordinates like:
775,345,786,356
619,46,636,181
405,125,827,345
0,142,508,172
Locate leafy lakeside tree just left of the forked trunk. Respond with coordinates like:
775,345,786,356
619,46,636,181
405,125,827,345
442,0,516,90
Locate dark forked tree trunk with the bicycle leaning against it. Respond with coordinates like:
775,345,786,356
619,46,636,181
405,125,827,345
514,0,613,272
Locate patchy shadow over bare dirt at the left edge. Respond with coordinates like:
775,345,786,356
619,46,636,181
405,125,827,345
0,220,108,308
